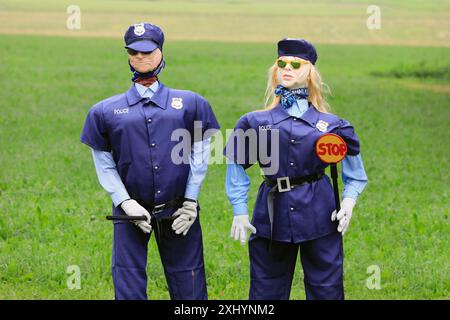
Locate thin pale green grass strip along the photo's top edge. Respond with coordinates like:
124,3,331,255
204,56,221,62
0,0,450,17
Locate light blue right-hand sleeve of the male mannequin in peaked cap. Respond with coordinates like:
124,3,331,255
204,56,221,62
184,138,211,200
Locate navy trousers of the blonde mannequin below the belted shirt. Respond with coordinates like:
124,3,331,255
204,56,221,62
249,232,344,300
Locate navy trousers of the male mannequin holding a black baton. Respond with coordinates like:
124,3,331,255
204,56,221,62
112,211,208,300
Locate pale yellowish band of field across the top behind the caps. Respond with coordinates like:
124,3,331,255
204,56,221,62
0,0,450,47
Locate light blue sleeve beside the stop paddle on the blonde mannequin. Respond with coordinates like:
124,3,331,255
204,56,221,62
342,154,368,201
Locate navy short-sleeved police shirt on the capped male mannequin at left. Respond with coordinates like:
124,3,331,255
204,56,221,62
80,83,220,215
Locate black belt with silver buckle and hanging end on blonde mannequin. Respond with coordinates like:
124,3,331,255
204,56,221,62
264,172,325,252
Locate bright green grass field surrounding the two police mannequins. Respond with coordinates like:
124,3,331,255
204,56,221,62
0,1,450,299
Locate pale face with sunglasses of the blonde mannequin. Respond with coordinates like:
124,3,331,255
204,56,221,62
277,56,311,89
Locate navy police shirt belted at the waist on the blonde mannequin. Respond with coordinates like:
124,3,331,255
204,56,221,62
224,104,359,243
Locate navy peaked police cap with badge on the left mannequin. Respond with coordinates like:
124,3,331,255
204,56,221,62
124,23,164,52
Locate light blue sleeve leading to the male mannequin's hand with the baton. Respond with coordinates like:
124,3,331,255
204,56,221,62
91,148,130,207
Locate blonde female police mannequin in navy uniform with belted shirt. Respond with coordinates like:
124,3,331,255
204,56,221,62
224,39,367,299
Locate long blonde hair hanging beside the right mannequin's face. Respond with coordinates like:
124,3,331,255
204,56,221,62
264,63,331,113
